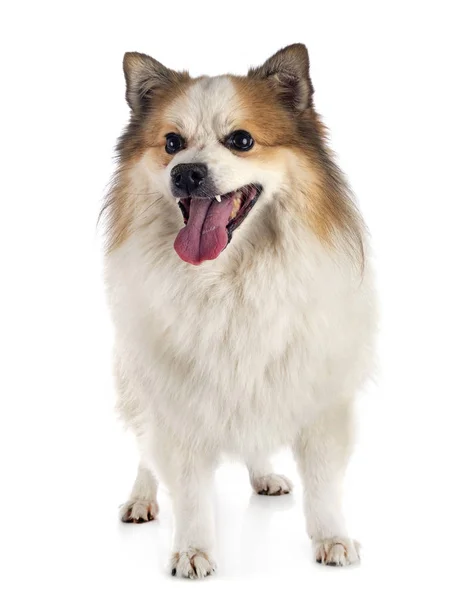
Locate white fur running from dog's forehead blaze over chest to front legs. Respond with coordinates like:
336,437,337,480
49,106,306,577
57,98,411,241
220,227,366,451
107,78,375,577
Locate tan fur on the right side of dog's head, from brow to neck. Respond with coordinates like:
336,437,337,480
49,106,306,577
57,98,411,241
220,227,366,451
232,77,364,265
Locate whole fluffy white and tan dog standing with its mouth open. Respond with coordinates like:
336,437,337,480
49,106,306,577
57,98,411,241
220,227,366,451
103,44,377,578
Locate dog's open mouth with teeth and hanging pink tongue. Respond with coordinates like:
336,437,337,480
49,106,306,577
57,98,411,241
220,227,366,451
174,184,262,265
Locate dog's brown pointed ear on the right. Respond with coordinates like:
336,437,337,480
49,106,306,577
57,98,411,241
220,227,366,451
248,44,313,112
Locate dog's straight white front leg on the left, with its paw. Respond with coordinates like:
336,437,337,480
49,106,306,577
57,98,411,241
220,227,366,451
168,448,216,579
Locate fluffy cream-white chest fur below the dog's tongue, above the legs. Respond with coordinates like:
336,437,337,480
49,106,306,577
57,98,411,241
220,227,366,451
108,199,374,451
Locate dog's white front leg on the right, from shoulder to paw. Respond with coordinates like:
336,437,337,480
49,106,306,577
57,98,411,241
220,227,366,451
294,404,359,566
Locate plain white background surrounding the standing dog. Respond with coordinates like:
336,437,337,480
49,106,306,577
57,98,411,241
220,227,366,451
0,0,470,600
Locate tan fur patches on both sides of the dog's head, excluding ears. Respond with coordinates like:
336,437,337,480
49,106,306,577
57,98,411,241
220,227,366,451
104,71,363,265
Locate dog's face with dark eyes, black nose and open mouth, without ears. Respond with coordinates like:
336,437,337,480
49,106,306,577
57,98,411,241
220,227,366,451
151,77,290,265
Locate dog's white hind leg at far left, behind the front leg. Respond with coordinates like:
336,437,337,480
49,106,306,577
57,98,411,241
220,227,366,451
120,464,158,523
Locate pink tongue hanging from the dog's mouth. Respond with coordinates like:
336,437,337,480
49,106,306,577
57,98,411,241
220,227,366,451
174,196,233,265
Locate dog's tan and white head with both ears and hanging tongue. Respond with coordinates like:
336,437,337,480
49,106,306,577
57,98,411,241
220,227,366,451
111,44,364,265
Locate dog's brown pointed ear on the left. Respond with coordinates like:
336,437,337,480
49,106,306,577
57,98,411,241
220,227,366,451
123,52,189,115
